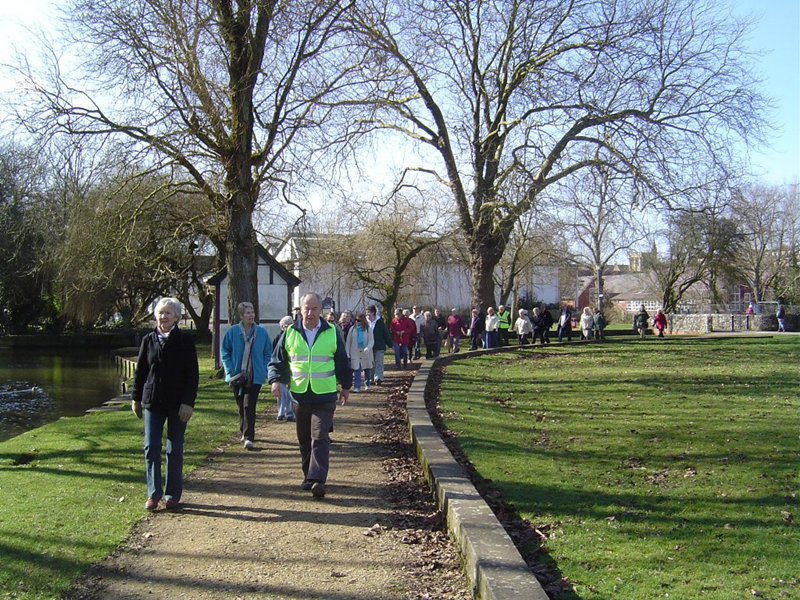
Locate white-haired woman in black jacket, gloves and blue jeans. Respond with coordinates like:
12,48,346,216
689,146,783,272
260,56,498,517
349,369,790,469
131,298,200,510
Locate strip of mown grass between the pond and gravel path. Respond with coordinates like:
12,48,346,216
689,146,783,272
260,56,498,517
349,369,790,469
0,346,238,600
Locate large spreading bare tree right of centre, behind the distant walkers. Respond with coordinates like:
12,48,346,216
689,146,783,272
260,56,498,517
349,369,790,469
355,0,767,306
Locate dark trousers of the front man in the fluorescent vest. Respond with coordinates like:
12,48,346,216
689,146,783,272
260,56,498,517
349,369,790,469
292,402,336,483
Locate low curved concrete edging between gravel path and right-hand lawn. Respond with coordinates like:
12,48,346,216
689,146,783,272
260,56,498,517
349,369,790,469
406,360,547,600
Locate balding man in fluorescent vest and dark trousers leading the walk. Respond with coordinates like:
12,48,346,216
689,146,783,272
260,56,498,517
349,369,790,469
268,293,353,498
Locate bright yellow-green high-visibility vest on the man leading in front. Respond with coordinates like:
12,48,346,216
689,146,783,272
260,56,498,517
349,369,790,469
284,327,337,394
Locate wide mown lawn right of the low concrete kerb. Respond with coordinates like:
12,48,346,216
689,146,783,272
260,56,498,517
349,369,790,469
441,336,800,600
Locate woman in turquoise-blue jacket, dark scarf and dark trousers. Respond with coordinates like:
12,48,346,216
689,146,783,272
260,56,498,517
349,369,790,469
220,302,272,450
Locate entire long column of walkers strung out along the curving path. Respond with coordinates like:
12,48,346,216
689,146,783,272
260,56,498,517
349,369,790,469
131,293,667,510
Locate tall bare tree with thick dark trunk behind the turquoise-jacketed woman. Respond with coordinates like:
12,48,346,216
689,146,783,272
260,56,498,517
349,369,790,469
12,0,351,322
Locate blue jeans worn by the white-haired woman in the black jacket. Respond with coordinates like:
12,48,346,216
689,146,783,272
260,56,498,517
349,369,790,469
143,406,186,501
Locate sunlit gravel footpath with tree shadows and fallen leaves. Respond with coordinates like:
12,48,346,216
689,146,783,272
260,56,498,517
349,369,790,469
65,371,472,600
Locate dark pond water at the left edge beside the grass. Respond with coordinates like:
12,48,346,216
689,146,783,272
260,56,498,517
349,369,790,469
0,348,122,442
